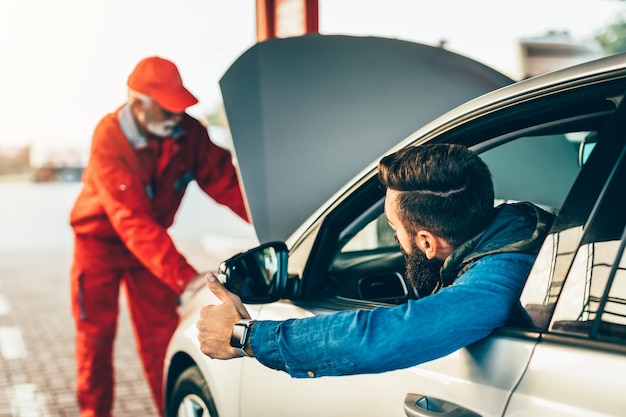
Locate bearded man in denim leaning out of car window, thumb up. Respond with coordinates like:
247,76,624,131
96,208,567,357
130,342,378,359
196,144,553,377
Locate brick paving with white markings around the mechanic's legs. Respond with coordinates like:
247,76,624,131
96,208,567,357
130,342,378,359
0,252,156,417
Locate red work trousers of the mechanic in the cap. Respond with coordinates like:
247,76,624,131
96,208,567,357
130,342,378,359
71,237,179,417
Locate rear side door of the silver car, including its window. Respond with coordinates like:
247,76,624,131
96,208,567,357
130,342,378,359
506,88,626,417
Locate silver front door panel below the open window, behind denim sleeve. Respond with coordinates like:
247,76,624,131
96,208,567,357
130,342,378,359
239,229,534,417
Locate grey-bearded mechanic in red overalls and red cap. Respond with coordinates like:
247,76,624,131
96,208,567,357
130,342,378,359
70,57,248,417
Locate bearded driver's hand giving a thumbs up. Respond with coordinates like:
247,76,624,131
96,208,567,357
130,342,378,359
196,272,250,359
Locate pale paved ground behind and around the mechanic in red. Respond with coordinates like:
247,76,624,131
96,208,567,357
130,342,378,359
0,184,253,417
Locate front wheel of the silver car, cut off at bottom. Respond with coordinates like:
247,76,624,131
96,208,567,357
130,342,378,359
167,366,217,417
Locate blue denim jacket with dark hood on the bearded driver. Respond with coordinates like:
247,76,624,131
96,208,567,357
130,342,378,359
250,203,552,378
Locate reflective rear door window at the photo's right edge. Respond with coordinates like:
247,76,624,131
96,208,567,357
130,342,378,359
549,150,626,342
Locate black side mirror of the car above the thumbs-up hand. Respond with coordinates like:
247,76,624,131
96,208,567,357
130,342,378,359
218,242,288,304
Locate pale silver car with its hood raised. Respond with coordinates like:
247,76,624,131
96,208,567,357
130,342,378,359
164,38,626,417
